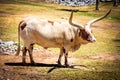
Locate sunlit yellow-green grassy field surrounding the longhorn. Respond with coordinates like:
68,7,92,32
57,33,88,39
0,0,120,80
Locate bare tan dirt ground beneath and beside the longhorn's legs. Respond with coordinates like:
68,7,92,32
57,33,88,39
0,49,120,80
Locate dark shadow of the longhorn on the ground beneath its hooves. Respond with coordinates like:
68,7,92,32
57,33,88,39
5,62,87,73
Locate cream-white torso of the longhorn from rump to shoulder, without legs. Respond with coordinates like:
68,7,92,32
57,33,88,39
20,17,75,47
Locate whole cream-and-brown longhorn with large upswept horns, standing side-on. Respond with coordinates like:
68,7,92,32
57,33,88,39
17,10,111,66
